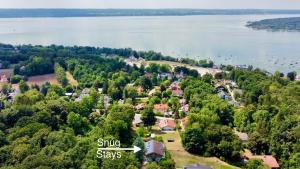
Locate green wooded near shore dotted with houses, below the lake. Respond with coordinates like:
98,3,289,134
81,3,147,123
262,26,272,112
0,44,300,169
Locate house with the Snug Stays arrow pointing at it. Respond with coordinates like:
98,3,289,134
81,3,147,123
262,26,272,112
145,140,165,162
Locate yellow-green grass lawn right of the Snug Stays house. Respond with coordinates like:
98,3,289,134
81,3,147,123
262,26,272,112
153,129,238,169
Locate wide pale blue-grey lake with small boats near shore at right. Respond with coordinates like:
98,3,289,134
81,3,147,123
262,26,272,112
0,15,300,73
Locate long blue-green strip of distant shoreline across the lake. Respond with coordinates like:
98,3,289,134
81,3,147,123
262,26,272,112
0,8,300,18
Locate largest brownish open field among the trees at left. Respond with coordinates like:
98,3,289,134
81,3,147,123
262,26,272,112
26,74,59,86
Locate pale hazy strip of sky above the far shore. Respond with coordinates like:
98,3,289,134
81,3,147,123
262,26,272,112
0,0,300,9
